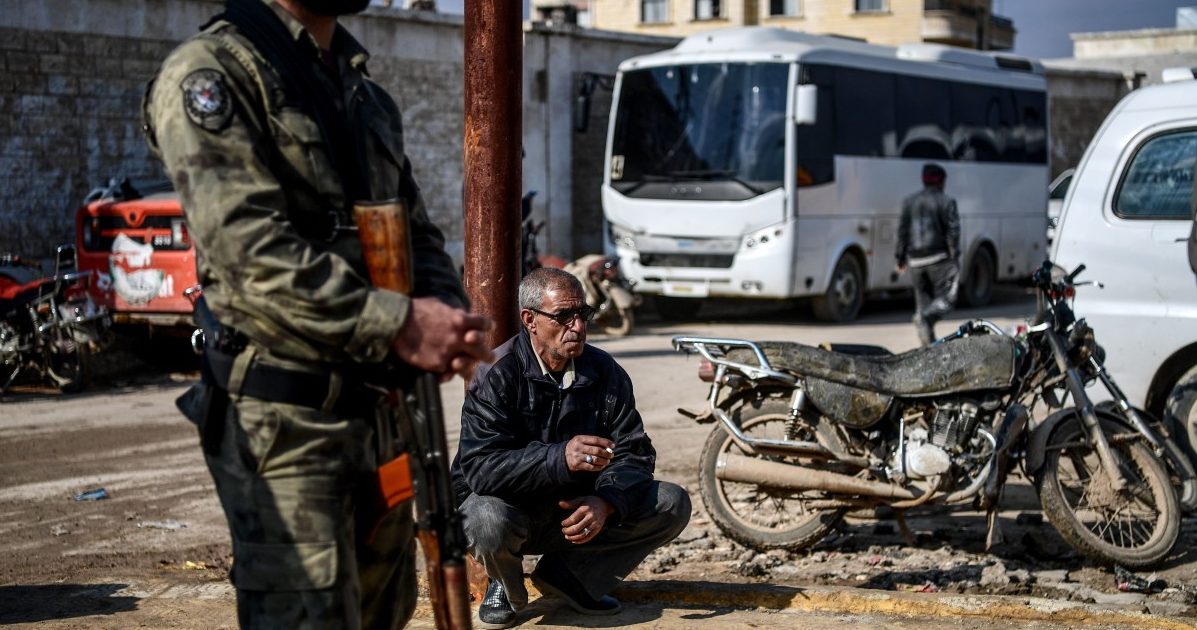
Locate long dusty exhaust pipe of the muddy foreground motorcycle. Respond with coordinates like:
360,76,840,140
715,453,919,499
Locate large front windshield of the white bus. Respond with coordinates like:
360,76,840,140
610,62,790,201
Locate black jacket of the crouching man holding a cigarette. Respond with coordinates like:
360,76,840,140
452,329,656,522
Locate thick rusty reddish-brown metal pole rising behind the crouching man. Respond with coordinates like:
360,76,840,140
464,0,523,347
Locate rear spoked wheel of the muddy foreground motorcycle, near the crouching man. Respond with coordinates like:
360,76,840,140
698,395,847,551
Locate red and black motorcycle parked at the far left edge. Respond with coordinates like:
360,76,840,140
0,246,111,395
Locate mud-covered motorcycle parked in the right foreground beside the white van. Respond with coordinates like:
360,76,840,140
673,262,1193,568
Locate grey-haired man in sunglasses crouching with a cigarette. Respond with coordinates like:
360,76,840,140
452,267,691,628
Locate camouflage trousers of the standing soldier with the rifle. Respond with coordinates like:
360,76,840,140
180,384,417,629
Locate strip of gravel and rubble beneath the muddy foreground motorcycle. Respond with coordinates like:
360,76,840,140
632,505,1197,616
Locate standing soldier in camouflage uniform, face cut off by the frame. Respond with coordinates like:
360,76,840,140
145,0,491,628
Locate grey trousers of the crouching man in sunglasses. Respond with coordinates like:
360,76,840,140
461,481,691,611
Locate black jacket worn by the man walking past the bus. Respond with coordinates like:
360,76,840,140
895,186,960,265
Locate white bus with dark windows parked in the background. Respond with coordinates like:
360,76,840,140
602,28,1049,321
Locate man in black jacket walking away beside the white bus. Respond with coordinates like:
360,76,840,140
897,164,960,346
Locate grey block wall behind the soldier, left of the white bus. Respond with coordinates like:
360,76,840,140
0,0,673,258
